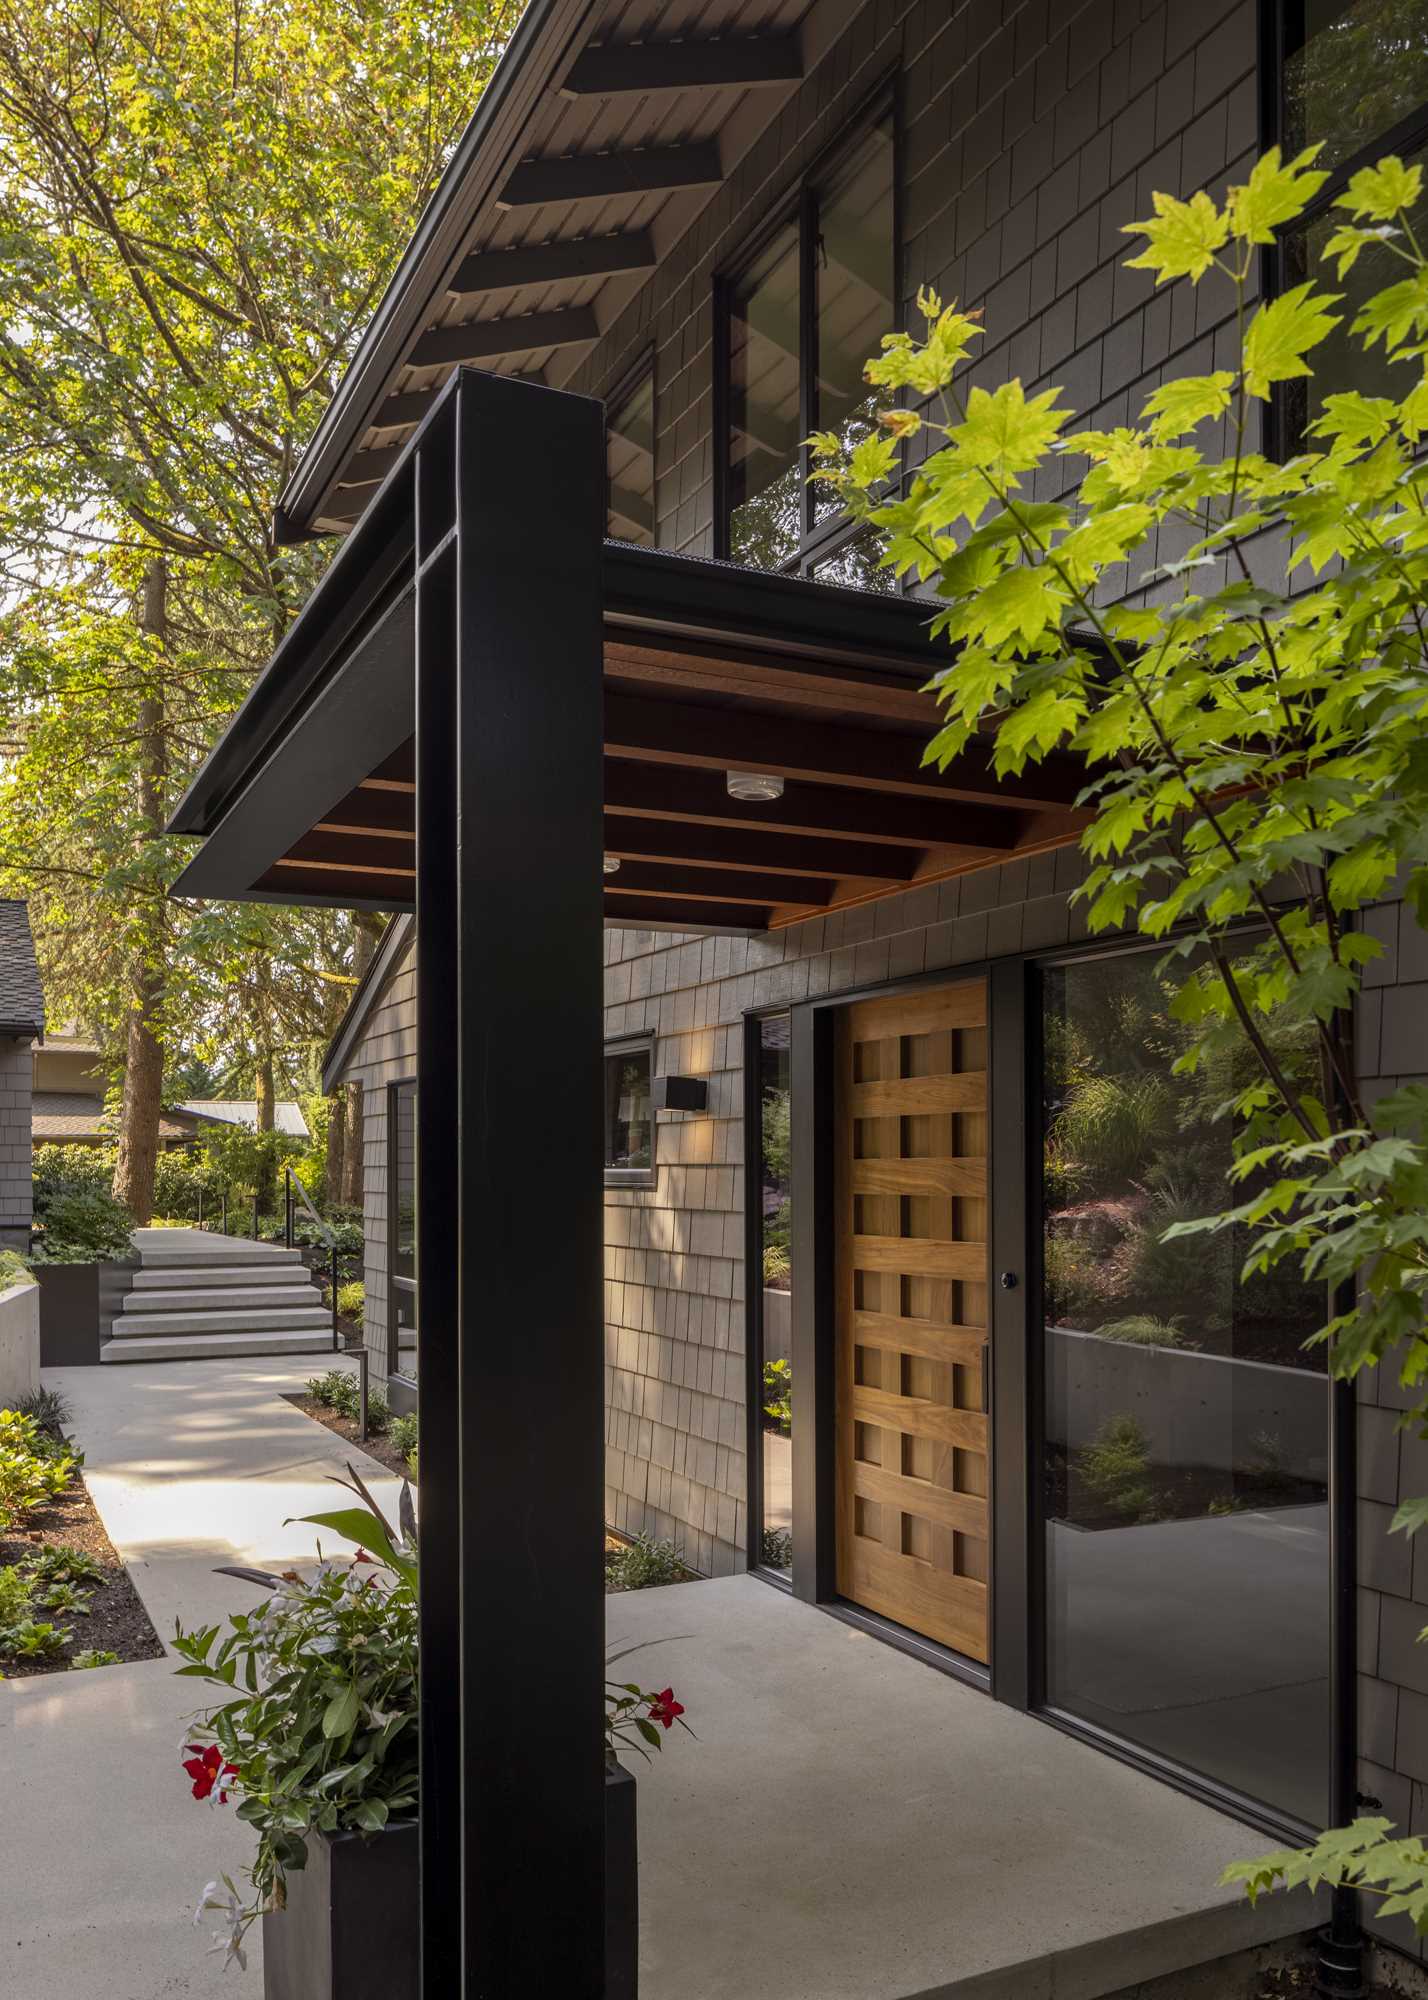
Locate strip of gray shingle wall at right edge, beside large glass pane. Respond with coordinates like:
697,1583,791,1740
1358,900,1428,1954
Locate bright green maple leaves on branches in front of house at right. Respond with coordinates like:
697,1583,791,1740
816,148,1428,1928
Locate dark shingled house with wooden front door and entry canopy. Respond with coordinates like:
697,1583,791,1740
161,0,1428,1984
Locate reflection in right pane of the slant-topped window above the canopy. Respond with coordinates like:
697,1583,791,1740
814,116,894,524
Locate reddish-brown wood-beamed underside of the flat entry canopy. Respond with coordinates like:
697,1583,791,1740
254,628,1086,930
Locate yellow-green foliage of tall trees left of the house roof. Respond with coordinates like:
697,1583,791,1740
0,0,518,1220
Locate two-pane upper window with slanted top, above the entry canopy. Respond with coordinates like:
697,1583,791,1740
720,110,896,590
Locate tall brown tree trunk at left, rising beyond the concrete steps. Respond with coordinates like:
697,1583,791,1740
114,560,168,1226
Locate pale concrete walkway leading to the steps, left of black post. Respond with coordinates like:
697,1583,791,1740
0,1356,398,2000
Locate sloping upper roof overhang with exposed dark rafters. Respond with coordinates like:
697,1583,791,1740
278,0,844,540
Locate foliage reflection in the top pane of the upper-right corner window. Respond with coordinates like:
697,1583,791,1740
1284,0,1428,168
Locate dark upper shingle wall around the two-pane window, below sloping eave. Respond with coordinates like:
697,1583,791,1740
572,0,1258,556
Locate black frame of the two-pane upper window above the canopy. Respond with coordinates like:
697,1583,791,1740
714,86,906,594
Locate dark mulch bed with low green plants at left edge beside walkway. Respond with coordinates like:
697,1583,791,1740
0,1408,164,1680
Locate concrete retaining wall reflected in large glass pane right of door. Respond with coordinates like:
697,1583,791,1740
1046,1326,1328,1480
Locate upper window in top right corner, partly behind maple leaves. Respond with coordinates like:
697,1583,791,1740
1280,0,1428,448
